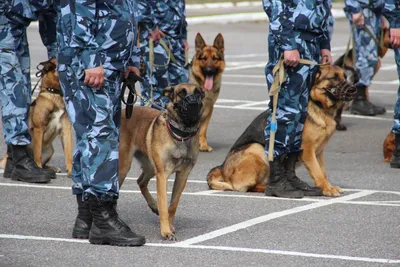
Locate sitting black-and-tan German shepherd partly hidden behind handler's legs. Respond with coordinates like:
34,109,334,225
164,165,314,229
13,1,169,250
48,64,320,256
207,65,356,196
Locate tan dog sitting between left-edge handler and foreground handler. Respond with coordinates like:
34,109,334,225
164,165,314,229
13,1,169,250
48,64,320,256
0,60,72,176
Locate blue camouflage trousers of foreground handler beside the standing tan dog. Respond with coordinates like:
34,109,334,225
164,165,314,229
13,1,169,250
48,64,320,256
58,63,122,199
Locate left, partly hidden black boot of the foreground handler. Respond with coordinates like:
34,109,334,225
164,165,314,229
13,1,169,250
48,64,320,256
72,194,93,239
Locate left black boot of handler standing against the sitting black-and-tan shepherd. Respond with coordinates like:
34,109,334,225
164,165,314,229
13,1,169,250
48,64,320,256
264,155,304,198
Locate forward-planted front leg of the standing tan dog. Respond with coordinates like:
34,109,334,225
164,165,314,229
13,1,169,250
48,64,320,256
156,170,176,241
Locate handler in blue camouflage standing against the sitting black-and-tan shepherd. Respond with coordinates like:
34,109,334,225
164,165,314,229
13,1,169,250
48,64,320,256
263,0,332,198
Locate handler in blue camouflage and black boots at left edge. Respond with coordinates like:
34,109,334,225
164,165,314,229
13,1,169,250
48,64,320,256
0,0,57,183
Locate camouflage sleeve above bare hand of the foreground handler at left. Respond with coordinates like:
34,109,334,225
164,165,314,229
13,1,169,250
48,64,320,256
69,0,102,69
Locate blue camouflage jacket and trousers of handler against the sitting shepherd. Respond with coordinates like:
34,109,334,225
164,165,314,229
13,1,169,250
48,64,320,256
263,0,331,157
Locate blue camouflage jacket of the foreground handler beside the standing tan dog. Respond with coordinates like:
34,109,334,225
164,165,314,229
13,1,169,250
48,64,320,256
57,0,140,71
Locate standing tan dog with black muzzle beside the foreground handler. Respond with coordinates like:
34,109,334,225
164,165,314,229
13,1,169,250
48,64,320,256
119,84,205,240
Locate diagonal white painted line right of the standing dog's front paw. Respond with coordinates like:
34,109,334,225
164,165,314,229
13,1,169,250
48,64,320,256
177,190,374,245
